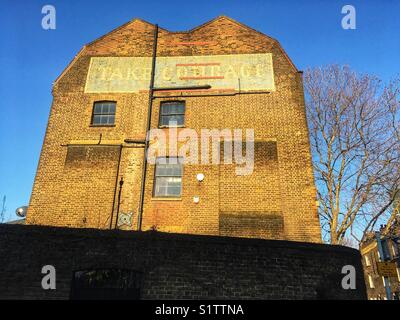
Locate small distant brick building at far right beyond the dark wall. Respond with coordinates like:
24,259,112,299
360,217,400,300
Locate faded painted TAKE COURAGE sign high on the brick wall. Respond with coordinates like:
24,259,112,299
85,53,275,93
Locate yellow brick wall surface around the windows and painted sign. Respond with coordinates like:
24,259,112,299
27,17,321,242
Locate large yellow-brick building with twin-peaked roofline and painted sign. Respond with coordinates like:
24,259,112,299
26,16,321,242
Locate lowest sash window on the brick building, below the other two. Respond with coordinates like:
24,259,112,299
153,157,182,198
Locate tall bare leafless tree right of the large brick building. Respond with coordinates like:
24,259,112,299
304,65,400,244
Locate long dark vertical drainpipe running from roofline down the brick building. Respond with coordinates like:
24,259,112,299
138,24,158,231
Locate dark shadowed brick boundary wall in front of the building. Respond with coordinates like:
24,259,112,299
0,225,366,299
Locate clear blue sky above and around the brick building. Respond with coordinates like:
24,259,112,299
0,0,400,219
